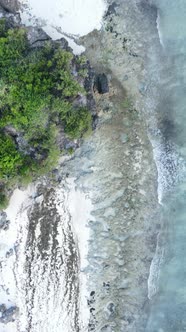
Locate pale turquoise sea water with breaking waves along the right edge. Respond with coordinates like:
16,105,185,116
146,0,186,332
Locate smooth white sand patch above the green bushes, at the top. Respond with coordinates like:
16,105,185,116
21,0,107,54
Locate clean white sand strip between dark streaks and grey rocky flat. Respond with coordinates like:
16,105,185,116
56,178,93,331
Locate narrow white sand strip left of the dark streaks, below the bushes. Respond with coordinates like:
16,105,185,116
0,186,33,332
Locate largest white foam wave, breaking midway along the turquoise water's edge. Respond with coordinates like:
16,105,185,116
144,74,186,204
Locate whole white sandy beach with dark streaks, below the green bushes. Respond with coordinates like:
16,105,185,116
0,179,92,332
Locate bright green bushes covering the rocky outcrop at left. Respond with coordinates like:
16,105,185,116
0,19,92,206
